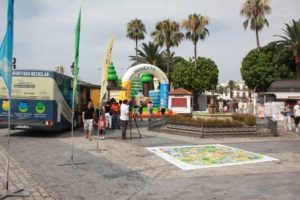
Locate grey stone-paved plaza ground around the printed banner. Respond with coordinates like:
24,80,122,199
0,123,300,200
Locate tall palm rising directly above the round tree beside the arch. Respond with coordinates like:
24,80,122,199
182,13,209,67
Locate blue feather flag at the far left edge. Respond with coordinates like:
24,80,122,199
0,0,14,96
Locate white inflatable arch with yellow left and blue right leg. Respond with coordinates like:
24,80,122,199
121,64,169,108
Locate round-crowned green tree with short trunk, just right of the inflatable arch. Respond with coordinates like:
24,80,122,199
172,57,219,110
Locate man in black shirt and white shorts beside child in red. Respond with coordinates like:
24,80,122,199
82,100,94,141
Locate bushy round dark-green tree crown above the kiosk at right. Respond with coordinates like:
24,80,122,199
241,42,295,92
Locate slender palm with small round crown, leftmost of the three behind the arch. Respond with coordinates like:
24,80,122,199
127,19,146,61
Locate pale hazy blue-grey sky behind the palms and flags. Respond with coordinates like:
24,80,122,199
0,0,300,84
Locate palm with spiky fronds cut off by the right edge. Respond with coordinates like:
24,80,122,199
276,19,300,79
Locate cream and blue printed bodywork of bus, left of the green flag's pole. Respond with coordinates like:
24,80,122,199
0,70,72,129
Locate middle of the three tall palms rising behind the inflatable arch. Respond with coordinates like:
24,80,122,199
151,19,184,80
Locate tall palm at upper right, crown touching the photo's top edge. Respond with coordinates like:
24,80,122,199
240,0,271,49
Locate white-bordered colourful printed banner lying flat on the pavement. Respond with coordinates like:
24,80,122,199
146,144,278,170
